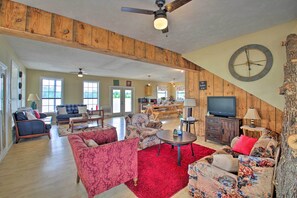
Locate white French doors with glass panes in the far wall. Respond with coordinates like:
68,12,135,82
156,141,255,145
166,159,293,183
110,87,134,116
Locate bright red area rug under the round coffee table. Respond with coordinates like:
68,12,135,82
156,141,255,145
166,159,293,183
126,144,215,198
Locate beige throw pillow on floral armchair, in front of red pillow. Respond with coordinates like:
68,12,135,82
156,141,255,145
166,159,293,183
212,154,238,172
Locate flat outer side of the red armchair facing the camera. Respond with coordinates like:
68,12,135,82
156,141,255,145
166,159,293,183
76,138,139,195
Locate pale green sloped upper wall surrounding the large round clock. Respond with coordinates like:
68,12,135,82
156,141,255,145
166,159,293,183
183,20,297,110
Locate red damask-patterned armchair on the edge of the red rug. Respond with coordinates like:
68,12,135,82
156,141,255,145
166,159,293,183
68,128,139,198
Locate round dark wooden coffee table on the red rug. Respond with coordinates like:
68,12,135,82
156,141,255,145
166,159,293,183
156,130,197,166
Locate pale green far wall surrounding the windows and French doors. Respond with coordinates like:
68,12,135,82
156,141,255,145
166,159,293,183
26,69,183,112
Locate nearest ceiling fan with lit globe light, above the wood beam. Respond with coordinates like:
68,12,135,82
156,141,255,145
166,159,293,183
121,0,192,33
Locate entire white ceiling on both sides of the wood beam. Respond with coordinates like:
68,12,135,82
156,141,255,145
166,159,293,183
8,0,297,82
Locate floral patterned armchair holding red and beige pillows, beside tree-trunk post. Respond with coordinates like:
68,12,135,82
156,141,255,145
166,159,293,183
188,130,280,198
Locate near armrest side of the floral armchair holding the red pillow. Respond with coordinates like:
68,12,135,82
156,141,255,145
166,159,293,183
237,155,275,197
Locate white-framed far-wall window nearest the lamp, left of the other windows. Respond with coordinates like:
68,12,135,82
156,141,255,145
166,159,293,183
41,78,62,112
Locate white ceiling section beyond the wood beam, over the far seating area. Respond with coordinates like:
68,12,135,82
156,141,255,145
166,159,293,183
3,36,184,82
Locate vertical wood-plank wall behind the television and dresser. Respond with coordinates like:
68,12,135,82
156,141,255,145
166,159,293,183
185,70,283,136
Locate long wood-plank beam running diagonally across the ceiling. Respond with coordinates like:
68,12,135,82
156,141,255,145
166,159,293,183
0,0,201,71
